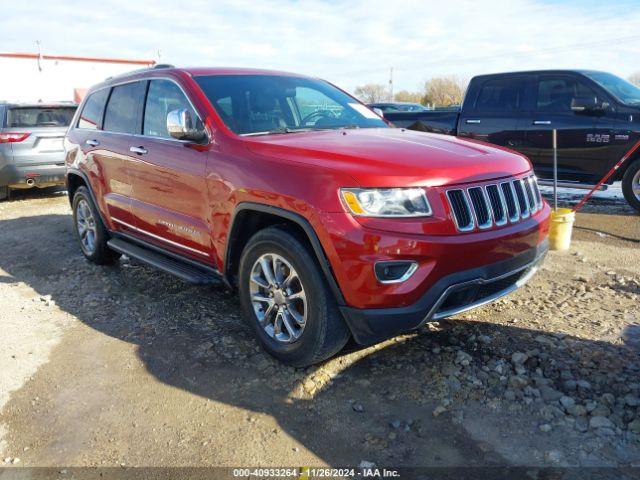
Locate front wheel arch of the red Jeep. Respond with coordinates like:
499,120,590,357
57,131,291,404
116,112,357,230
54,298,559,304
224,202,345,305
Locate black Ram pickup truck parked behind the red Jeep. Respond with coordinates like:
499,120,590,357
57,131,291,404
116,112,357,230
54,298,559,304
384,70,640,211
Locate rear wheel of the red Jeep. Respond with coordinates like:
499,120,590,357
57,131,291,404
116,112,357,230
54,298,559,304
72,187,120,265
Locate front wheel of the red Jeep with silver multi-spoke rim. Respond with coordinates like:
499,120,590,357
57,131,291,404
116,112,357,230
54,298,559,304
239,227,350,367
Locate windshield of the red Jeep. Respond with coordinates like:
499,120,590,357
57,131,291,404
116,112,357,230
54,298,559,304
195,75,388,135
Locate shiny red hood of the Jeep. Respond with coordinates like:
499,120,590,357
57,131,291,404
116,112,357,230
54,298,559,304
244,128,531,187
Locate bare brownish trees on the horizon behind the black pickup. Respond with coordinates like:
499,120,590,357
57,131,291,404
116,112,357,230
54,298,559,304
354,72,640,108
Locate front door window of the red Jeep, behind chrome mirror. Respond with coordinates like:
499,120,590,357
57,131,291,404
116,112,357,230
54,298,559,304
142,80,198,138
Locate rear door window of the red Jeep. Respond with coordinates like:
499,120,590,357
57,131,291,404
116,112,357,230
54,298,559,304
103,82,145,133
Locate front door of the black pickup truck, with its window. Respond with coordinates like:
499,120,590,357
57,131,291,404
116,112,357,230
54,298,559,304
524,73,611,183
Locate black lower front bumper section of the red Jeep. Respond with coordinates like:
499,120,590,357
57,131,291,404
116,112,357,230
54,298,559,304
340,240,548,345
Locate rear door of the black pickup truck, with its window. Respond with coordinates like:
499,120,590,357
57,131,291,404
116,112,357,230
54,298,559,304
458,75,527,149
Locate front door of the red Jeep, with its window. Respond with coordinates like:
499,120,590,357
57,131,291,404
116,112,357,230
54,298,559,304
129,79,213,262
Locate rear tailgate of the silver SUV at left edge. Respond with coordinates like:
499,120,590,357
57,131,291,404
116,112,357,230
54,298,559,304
3,105,76,181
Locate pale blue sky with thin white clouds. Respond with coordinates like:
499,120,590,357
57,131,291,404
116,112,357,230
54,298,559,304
0,0,640,91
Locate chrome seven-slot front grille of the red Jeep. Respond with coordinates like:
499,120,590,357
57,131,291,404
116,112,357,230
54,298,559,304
446,175,543,232
